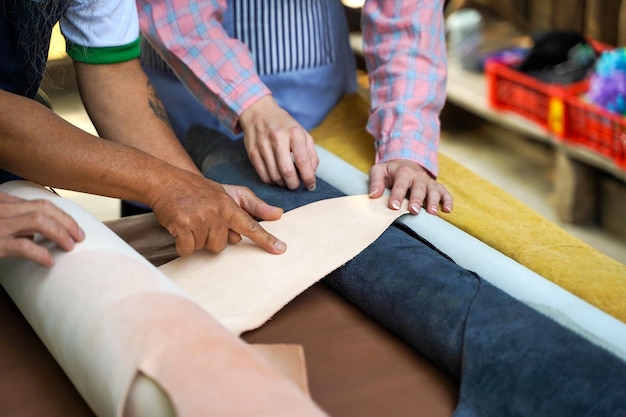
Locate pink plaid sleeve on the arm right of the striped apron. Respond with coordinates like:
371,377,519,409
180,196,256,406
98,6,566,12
362,0,447,176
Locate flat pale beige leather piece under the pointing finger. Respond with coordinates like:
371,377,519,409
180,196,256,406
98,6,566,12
159,195,407,334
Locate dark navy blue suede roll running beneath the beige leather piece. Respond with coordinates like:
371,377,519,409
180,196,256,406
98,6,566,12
186,128,626,417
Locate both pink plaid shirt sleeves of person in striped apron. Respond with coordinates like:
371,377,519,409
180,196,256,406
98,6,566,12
137,0,447,176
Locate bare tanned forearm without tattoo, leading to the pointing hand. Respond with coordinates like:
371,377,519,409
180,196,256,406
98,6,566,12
0,91,190,205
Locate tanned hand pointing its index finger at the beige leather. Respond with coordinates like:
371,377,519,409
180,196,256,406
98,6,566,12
152,173,287,256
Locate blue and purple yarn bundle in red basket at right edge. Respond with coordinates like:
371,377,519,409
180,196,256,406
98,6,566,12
587,47,626,116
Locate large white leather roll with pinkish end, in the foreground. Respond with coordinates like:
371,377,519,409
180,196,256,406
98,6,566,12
0,181,332,417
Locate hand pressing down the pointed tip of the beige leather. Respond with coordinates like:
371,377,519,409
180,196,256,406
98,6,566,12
369,159,452,214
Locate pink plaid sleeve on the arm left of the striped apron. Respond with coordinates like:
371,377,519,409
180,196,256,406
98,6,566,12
137,0,271,132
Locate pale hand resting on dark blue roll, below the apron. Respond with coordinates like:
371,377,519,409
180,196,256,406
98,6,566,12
239,96,319,191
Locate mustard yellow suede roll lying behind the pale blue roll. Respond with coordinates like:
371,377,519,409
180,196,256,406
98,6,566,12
311,94,626,323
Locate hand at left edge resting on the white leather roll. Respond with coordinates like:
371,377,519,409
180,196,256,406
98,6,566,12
0,191,85,267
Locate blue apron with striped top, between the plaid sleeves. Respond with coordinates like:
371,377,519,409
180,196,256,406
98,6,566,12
143,0,356,141
